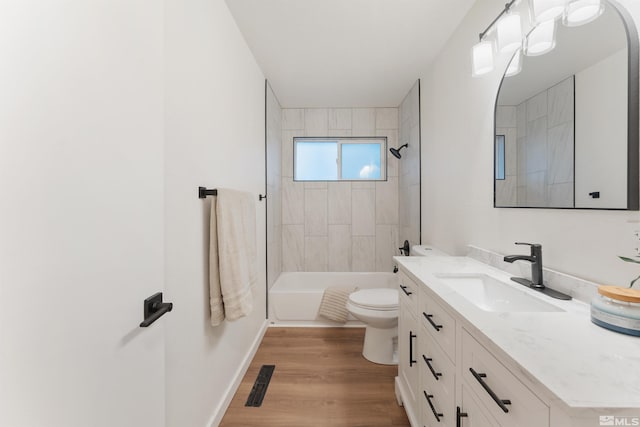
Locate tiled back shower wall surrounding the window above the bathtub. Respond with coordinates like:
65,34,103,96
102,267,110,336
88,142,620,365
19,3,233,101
281,108,405,271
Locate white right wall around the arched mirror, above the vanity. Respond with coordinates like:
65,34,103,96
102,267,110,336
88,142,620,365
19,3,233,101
421,0,640,285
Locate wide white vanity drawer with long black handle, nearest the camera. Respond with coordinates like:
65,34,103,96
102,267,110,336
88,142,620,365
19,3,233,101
462,329,549,427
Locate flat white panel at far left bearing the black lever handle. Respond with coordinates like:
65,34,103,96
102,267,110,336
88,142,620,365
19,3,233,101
0,0,165,427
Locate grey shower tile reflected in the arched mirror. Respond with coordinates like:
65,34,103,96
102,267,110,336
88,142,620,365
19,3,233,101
496,76,574,207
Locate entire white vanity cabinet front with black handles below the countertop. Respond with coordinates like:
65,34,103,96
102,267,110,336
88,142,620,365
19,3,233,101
397,272,550,427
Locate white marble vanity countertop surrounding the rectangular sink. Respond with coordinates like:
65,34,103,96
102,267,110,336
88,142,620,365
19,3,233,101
394,255,640,414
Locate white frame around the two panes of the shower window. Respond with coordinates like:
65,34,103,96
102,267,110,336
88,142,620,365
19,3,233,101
292,136,389,182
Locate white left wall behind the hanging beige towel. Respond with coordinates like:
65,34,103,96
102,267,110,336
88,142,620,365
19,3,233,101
164,0,266,427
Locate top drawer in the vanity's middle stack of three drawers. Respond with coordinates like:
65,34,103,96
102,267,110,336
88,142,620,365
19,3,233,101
418,291,456,362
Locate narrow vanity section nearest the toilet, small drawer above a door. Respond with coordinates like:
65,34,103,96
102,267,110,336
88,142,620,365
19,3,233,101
396,273,420,425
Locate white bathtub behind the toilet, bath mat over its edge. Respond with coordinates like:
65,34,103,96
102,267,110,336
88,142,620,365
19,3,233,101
269,272,397,326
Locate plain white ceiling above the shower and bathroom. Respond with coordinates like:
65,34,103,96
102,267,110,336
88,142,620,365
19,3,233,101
226,0,475,108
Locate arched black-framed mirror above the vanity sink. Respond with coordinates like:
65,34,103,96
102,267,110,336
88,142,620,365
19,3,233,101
494,0,639,210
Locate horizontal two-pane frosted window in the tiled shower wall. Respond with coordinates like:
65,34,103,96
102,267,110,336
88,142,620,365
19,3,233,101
293,137,387,181
